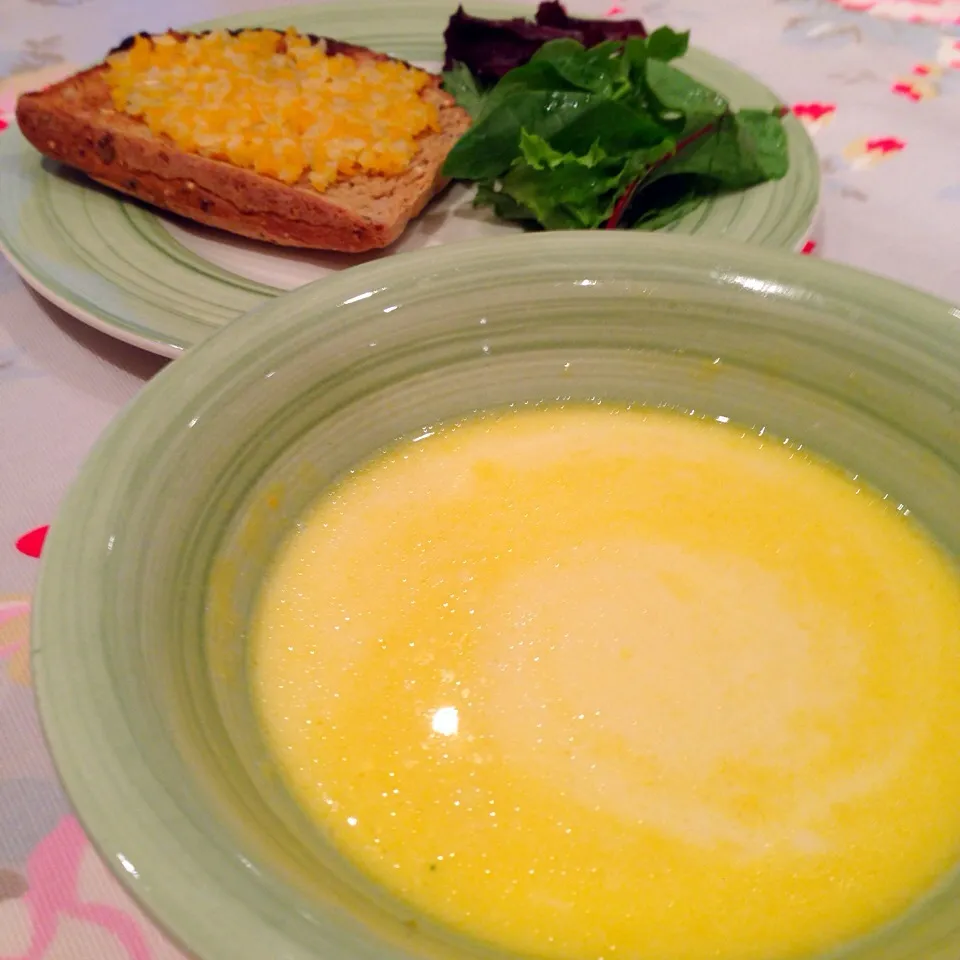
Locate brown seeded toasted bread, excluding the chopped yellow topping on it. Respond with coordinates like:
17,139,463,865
17,32,470,253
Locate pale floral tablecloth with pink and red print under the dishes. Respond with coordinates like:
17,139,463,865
0,0,960,960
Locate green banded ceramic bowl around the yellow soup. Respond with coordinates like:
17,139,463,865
32,233,960,960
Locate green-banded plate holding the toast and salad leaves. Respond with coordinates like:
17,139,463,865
0,0,820,357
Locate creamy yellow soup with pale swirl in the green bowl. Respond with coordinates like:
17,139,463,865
252,407,960,960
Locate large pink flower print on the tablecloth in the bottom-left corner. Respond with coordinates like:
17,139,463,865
0,816,183,960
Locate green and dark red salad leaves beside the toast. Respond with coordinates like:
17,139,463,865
444,3,788,230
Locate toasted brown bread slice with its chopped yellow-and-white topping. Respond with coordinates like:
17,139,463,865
17,29,470,253
